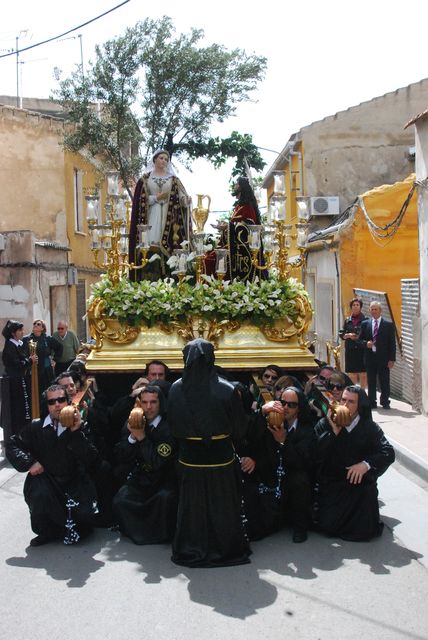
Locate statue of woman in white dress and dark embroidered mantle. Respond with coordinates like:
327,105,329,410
129,149,190,280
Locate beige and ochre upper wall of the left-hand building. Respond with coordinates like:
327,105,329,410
0,105,103,330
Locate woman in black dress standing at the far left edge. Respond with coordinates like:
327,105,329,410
2,320,37,433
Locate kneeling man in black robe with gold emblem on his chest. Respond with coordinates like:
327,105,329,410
113,385,177,544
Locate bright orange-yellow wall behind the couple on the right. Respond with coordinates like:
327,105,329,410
339,176,419,329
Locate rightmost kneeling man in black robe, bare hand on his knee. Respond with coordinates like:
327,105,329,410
315,385,395,540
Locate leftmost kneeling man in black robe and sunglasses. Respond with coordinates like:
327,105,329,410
6,385,100,547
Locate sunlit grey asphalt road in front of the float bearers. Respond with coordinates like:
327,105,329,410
0,467,428,640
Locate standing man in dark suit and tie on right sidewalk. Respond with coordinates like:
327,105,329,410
358,300,395,409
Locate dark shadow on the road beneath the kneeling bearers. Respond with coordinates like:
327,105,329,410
6,518,421,619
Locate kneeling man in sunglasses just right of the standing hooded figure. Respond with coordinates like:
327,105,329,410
262,387,315,543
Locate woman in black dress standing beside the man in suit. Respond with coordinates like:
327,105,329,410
339,298,367,389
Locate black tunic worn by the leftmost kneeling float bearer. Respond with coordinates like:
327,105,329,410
6,420,100,536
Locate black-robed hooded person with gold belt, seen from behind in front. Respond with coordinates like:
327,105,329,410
168,339,250,567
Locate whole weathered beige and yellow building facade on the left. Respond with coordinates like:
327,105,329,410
0,101,102,360
